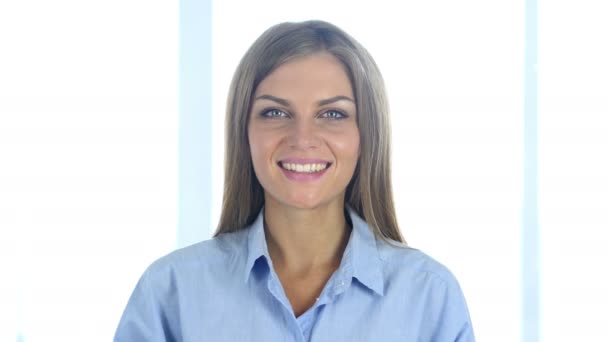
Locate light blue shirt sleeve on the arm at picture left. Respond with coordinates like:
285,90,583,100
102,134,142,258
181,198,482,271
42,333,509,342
114,269,178,342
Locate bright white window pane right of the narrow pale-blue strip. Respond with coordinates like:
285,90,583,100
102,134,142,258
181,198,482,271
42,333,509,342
538,0,608,341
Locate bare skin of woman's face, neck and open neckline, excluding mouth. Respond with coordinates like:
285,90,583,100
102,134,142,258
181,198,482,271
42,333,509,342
248,52,359,316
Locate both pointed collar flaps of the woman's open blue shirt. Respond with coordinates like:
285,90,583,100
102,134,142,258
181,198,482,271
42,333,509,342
245,208,384,296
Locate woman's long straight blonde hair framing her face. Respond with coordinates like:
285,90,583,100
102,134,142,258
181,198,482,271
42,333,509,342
214,20,405,243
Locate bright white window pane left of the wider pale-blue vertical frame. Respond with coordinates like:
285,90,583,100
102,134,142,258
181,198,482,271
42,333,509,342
0,0,179,342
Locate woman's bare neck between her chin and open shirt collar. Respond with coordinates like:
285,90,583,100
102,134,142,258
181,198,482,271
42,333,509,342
264,199,350,275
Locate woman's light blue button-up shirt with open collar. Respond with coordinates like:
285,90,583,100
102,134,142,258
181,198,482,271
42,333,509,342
114,210,475,342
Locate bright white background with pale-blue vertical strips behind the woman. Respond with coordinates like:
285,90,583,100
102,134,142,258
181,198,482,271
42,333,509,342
0,0,608,342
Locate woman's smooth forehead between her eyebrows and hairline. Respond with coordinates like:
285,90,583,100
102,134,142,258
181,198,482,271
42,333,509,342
256,52,353,98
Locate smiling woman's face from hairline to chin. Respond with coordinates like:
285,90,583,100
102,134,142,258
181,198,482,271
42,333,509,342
248,53,359,209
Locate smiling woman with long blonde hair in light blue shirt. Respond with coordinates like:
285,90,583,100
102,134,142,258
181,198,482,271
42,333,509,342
115,21,474,341
